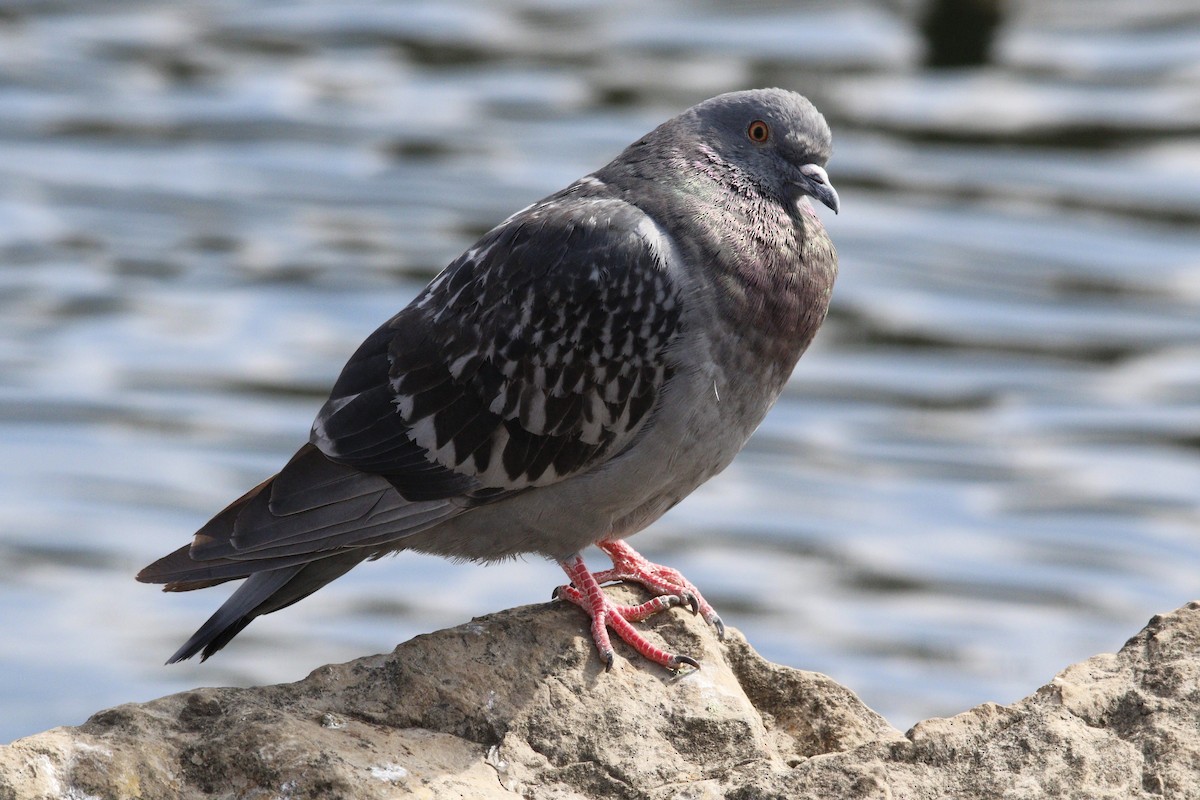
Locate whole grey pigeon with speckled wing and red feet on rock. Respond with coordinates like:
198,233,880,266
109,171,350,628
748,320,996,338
137,89,839,670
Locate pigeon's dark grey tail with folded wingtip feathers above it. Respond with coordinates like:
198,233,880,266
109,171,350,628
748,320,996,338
138,445,462,663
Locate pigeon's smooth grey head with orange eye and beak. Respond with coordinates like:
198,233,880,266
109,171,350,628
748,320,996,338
668,89,840,213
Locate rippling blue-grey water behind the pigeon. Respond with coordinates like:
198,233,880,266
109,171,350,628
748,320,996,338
0,0,1200,740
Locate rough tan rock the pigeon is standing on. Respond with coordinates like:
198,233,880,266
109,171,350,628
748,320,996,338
0,587,1200,800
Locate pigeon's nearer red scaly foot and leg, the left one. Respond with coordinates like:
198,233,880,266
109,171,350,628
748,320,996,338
556,554,700,669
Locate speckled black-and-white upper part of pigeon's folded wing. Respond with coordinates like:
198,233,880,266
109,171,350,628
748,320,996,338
312,195,679,500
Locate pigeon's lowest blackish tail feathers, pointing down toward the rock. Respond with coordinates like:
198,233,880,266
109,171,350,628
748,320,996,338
167,552,367,664
